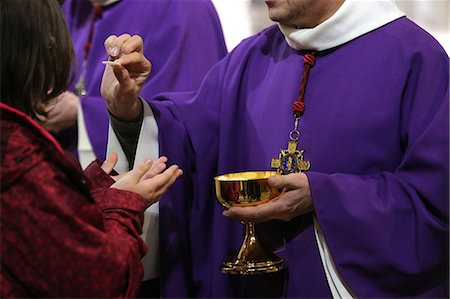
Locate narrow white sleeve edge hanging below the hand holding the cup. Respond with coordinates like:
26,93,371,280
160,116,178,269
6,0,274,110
314,217,355,299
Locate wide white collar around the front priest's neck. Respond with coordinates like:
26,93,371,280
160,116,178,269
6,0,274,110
278,0,405,51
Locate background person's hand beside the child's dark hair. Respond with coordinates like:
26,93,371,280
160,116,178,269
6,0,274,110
40,91,80,133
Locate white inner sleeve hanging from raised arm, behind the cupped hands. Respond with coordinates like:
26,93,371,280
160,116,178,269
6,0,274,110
107,100,159,280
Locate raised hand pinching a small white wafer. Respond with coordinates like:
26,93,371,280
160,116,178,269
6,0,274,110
101,34,152,121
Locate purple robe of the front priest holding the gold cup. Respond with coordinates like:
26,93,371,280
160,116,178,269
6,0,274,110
150,17,449,298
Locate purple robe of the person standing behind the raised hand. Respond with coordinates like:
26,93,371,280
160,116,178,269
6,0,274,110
63,0,227,159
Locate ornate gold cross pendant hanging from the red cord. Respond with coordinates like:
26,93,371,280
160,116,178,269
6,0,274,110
271,140,311,174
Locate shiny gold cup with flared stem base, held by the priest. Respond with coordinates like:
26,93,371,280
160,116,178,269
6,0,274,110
214,171,285,275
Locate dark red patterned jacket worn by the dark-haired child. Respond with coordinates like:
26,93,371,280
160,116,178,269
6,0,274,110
0,103,147,298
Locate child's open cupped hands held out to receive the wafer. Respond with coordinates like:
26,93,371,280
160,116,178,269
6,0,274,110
111,159,183,206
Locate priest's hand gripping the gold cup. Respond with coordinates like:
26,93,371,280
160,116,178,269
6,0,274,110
223,173,314,223
